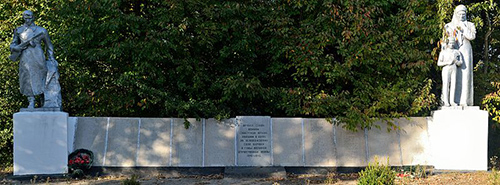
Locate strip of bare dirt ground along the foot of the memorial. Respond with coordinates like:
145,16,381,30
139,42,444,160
0,172,494,185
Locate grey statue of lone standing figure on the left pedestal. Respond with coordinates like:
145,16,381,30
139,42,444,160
9,10,61,110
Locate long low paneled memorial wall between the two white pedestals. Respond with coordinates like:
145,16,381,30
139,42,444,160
68,116,430,167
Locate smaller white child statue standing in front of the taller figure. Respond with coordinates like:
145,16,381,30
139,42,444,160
438,37,463,107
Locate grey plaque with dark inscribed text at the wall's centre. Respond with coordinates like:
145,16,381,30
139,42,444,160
236,116,272,166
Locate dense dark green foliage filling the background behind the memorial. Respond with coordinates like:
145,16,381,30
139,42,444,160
0,0,500,168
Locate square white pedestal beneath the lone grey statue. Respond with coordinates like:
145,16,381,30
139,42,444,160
14,112,68,175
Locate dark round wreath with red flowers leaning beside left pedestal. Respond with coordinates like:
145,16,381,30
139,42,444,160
68,149,94,177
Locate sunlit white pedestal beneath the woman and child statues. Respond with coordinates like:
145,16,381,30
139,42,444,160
428,108,488,170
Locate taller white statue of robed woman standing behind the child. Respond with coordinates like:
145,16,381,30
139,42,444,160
444,5,476,106
